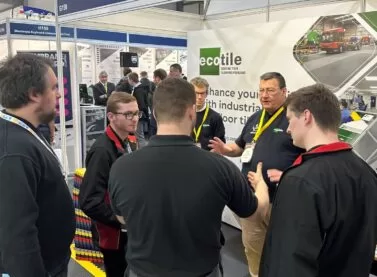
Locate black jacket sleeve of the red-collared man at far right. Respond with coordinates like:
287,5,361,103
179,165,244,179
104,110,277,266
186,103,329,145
259,177,326,277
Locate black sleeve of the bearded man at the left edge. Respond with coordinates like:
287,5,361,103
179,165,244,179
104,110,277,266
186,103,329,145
0,156,47,277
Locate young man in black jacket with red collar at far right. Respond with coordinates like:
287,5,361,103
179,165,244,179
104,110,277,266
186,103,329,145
260,84,377,277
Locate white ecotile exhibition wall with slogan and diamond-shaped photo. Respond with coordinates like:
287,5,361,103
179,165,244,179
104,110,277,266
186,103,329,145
188,12,377,227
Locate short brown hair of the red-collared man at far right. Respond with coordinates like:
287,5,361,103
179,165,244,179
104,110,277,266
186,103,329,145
285,84,341,132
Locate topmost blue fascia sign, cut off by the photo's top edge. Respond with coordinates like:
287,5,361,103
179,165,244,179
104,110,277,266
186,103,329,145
58,0,129,16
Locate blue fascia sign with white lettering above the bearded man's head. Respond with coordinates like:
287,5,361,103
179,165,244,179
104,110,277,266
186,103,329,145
10,22,75,38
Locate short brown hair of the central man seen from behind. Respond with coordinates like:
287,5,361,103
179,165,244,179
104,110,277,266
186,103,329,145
153,78,196,122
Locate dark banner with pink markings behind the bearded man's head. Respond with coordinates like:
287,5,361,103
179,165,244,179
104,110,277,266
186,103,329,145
19,51,72,124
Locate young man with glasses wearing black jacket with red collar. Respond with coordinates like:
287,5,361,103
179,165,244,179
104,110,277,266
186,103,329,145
79,92,140,277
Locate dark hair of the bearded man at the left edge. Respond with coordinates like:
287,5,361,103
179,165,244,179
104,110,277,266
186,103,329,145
0,53,53,109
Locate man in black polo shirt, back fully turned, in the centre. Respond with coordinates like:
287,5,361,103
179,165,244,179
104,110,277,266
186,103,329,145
109,78,269,277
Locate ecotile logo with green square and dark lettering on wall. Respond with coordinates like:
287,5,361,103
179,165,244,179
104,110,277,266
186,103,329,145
200,47,245,76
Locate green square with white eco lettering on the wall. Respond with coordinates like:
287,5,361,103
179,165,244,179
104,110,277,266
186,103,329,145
200,48,221,75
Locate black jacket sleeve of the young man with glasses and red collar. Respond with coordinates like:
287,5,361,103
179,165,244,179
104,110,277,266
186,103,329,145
79,147,120,227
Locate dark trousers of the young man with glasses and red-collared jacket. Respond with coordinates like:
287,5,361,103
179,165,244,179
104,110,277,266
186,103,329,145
101,232,127,277
